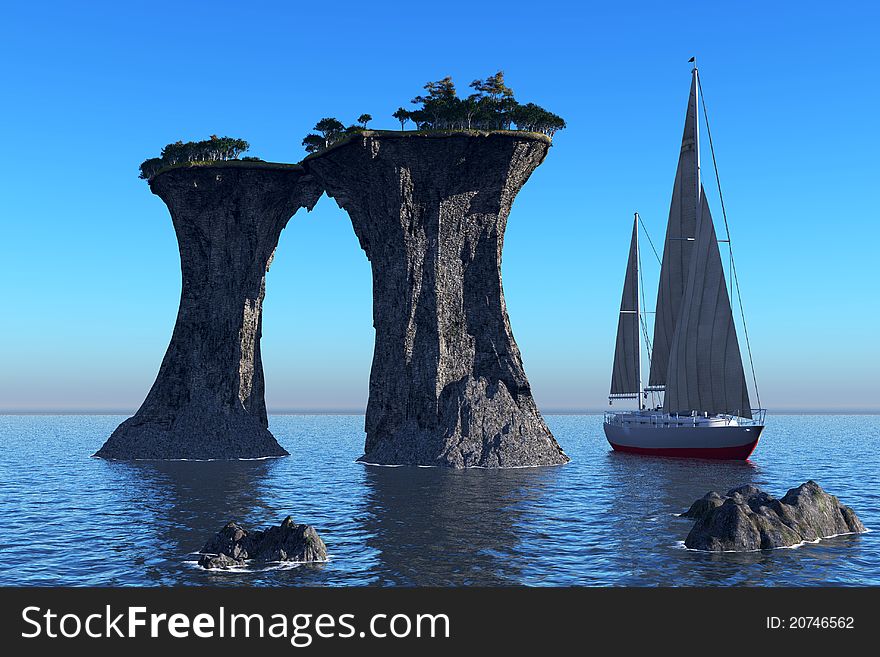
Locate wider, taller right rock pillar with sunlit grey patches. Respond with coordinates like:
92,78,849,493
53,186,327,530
303,132,568,467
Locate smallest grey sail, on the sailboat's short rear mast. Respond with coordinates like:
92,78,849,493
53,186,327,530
611,218,641,395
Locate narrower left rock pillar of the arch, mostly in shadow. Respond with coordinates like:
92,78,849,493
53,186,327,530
95,162,322,459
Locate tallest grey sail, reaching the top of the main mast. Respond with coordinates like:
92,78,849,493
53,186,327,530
648,73,699,386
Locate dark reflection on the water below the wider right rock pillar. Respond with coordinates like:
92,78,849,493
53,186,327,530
364,466,558,586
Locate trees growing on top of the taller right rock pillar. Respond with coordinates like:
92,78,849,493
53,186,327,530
302,71,565,153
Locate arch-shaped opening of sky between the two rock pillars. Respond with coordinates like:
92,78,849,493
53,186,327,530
262,194,375,414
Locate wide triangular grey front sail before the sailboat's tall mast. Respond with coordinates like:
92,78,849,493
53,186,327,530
654,189,752,418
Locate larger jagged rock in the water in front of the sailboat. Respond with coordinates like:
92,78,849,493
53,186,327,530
682,480,866,552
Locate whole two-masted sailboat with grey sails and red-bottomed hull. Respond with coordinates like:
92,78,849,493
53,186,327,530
604,60,766,460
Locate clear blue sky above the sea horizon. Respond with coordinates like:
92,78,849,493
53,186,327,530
0,0,880,411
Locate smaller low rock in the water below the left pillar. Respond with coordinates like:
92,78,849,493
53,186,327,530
199,516,327,568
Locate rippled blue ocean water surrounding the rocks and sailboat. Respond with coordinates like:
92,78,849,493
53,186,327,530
0,415,880,586
